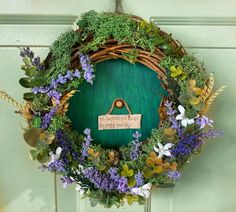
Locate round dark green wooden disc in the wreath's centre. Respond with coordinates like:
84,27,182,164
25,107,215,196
68,59,166,148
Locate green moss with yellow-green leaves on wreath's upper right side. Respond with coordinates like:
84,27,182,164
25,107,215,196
160,55,209,118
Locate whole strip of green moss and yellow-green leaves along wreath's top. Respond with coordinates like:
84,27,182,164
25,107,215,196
77,11,173,54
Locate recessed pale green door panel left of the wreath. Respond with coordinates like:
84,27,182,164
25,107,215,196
0,47,55,212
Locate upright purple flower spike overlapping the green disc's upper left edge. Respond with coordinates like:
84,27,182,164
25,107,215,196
79,53,95,84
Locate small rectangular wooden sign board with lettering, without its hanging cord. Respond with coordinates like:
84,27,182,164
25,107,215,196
98,114,142,130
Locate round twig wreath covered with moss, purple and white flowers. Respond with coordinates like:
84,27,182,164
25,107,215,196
1,11,224,207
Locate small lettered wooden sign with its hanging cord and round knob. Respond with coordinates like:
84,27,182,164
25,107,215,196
98,99,142,130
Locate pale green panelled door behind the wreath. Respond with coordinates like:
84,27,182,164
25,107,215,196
0,0,236,212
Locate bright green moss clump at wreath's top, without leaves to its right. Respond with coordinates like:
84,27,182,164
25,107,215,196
77,11,138,52
